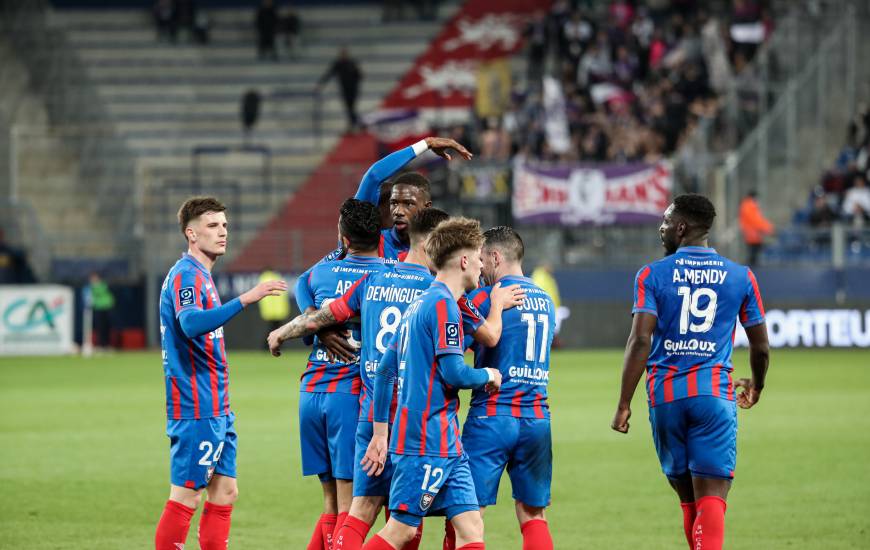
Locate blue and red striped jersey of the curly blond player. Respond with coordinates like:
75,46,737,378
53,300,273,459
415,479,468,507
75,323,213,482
390,281,463,457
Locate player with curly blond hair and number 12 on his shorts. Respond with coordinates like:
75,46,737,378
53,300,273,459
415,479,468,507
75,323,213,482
362,218,501,550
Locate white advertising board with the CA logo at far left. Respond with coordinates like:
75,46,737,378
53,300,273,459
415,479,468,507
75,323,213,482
0,285,74,355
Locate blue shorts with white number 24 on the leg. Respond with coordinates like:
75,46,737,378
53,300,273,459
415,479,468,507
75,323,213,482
166,412,237,489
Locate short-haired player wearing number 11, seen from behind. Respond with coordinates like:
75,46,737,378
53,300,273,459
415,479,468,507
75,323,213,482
460,226,556,550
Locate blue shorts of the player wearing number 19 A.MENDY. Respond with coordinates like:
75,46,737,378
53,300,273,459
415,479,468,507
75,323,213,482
649,395,737,479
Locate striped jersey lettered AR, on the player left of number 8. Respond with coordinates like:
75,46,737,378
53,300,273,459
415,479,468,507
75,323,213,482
300,255,385,394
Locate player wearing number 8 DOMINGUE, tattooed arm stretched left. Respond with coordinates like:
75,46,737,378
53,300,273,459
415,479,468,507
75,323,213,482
269,208,524,550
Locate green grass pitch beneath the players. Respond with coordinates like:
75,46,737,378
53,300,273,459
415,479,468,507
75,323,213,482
0,350,870,550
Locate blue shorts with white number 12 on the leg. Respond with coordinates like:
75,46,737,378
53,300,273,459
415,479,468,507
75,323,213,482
390,453,480,527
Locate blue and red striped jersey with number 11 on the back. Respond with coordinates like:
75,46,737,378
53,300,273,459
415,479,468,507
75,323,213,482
468,275,556,418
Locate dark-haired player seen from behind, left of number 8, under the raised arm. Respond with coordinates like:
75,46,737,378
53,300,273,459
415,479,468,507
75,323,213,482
299,199,383,550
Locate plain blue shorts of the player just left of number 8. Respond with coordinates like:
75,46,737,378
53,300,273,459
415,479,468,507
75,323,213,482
299,392,359,481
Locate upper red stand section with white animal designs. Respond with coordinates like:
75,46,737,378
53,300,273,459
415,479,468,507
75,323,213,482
383,0,550,109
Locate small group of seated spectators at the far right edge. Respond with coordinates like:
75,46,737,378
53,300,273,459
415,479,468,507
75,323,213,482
797,105,870,228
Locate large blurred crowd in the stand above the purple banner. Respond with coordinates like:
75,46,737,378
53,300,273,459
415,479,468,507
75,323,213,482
457,0,772,162
